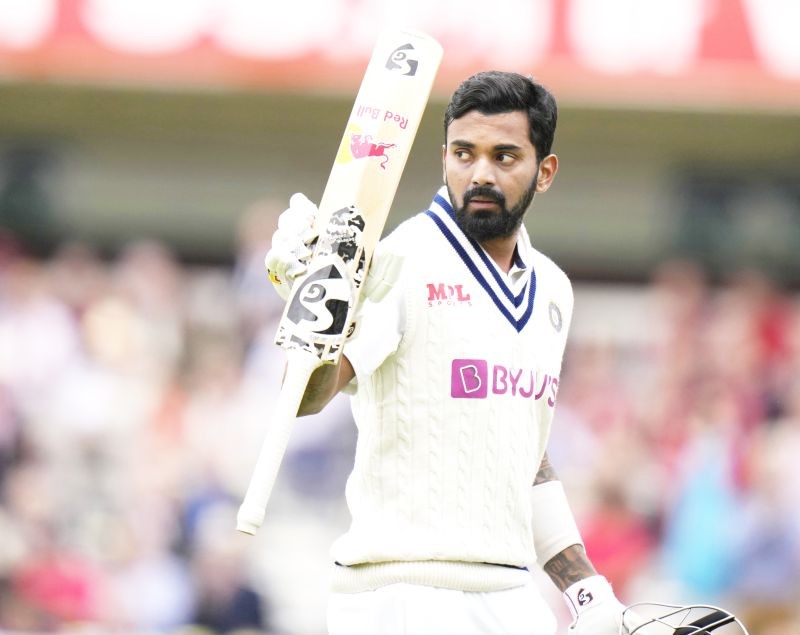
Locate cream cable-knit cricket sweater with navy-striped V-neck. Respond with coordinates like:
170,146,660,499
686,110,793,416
331,190,573,590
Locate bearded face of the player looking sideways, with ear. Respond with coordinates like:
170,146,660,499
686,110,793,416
442,110,558,242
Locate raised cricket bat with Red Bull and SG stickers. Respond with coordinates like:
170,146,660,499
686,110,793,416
236,30,443,534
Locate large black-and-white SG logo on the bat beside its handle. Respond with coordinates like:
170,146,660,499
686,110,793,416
286,263,351,335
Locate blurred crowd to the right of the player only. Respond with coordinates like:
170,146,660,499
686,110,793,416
553,261,800,635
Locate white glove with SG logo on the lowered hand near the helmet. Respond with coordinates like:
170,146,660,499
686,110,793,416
564,575,648,635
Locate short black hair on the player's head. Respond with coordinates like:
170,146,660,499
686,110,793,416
444,71,558,161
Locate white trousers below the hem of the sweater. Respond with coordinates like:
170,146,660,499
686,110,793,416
328,582,556,635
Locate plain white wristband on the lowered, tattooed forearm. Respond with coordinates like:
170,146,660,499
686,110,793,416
531,481,583,566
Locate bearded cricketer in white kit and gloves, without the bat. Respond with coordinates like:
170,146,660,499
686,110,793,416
266,71,644,635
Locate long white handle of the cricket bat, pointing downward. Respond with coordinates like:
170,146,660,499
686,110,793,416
236,349,321,535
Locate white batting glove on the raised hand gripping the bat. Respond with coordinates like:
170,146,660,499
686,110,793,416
264,193,318,300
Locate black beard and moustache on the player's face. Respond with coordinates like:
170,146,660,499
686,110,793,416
446,179,536,243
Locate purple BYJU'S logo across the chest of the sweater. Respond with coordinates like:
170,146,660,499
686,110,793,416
450,359,558,408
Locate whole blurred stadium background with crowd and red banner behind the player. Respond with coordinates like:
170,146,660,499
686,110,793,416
0,0,800,635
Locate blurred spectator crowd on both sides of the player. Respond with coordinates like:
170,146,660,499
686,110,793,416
0,202,800,635
